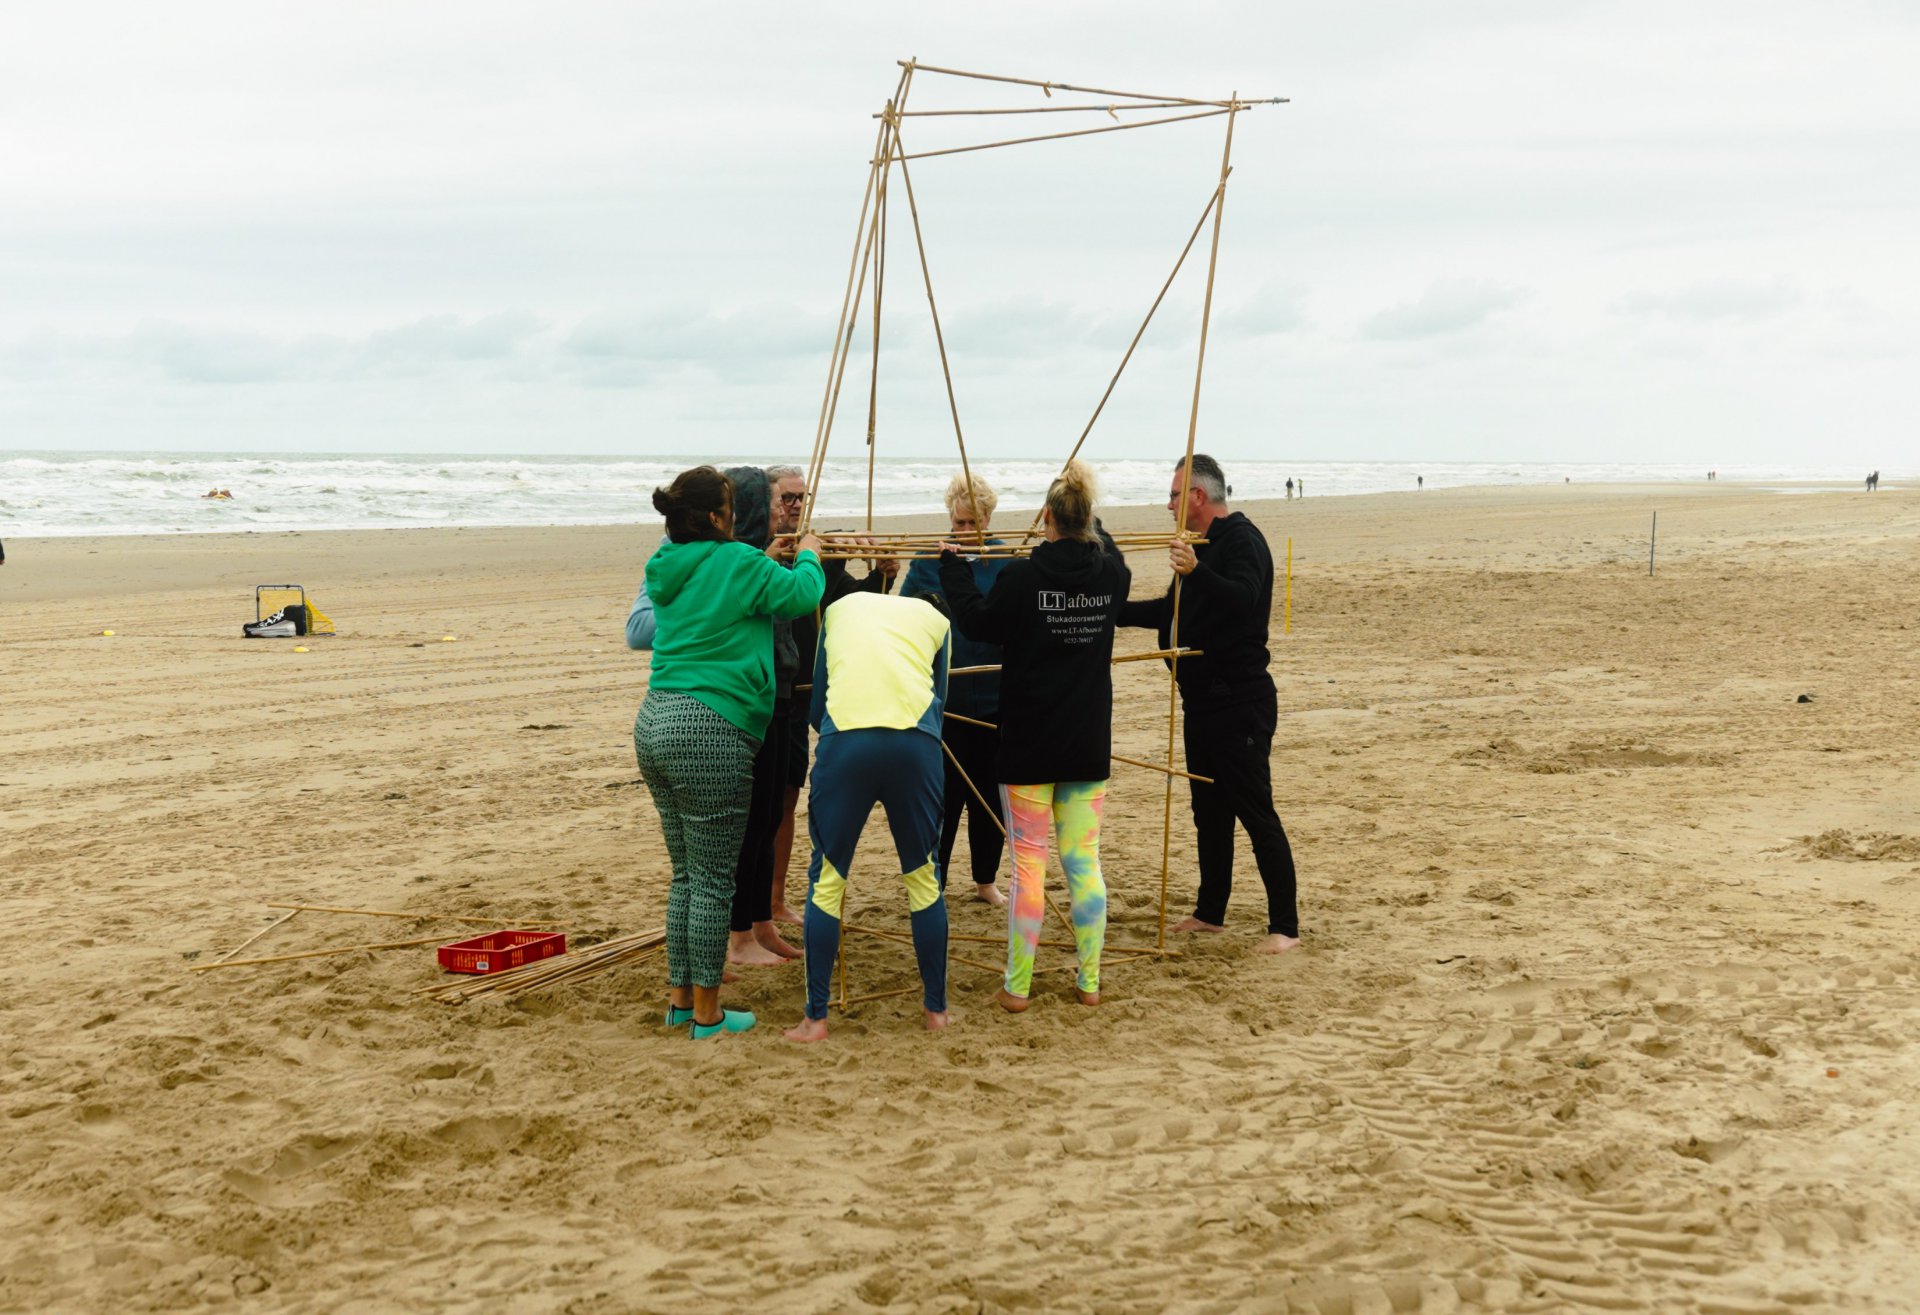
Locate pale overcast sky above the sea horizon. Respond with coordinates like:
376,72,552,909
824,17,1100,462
0,0,1920,466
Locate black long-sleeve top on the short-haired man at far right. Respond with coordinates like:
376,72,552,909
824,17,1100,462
1119,511,1273,708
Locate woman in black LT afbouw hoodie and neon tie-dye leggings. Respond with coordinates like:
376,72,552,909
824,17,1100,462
941,461,1129,1014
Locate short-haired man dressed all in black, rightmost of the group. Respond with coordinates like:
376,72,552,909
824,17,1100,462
1119,453,1300,954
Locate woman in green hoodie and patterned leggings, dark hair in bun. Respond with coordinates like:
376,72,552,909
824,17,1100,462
634,466,826,1037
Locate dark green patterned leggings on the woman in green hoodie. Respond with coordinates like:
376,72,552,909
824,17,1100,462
634,689,760,987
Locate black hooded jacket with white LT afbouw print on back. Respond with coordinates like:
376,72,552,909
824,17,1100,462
941,539,1129,785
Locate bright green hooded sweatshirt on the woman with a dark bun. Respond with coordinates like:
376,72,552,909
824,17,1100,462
647,539,828,739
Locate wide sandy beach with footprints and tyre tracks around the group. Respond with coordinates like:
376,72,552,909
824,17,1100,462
0,484,1920,1315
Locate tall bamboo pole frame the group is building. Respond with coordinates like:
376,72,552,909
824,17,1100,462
801,60,1284,1010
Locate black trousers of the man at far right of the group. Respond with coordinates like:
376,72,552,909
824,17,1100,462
1185,680,1300,937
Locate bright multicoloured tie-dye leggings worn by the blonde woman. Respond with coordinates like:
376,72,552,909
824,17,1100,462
1000,781,1106,998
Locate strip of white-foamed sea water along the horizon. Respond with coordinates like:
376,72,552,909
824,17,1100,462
0,451,1896,538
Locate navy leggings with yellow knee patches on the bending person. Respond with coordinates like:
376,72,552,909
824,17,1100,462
804,728,947,1019
